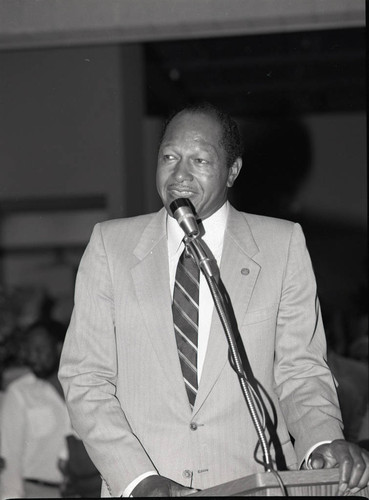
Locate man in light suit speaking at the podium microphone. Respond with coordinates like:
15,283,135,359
59,105,369,496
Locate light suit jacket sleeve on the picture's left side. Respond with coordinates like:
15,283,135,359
59,224,155,496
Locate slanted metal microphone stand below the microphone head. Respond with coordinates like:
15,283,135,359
184,233,274,472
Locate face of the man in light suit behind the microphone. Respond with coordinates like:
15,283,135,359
156,112,241,219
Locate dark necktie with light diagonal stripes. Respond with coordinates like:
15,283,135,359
172,244,200,408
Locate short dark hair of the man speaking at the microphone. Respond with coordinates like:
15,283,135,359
160,101,243,167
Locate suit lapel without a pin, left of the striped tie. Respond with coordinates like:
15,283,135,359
131,209,190,411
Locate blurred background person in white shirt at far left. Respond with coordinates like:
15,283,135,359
0,320,71,499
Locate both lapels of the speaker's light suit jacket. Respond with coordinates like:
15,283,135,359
131,206,260,415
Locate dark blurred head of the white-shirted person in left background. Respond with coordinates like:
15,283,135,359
24,321,65,379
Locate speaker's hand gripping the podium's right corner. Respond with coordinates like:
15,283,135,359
310,439,369,495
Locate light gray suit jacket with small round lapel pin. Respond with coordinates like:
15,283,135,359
59,207,343,496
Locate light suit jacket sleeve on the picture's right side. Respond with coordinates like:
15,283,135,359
274,224,343,462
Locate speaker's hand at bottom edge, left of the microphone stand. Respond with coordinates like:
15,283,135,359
131,476,198,497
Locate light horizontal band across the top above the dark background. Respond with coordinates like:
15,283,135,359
0,0,365,49
